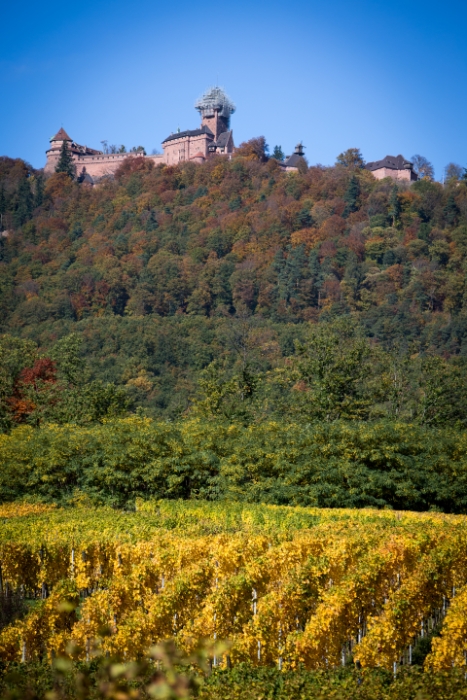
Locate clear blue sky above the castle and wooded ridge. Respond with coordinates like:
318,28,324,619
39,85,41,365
0,0,467,178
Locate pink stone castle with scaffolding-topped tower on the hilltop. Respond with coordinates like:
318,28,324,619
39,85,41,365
44,87,235,181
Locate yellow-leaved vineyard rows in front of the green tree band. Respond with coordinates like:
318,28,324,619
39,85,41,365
0,501,467,672
